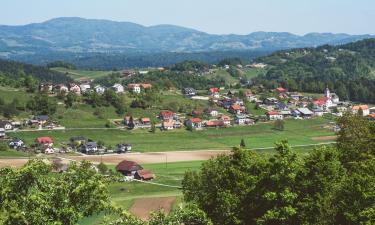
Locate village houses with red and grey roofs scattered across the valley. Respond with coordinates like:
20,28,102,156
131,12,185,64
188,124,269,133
0,75,375,154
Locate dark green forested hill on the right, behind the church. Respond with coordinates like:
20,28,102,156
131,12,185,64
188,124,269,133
256,39,375,103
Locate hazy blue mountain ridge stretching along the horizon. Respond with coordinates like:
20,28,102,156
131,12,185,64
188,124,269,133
0,17,374,63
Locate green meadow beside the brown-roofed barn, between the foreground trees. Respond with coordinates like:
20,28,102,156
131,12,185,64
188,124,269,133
79,161,202,225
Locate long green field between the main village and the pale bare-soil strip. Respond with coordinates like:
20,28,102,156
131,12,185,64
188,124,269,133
9,118,334,152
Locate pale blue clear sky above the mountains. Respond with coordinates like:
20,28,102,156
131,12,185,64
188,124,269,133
0,0,375,34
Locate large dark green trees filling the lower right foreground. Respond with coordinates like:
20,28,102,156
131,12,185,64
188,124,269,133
183,115,375,225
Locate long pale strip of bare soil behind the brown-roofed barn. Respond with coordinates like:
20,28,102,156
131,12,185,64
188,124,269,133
68,150,229,164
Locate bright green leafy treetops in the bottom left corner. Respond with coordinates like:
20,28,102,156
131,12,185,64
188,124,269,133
0,160,109,225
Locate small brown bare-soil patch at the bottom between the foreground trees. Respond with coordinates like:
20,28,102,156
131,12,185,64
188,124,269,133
129,197,176,220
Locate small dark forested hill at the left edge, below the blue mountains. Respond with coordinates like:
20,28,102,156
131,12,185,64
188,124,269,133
0,59,72,85
